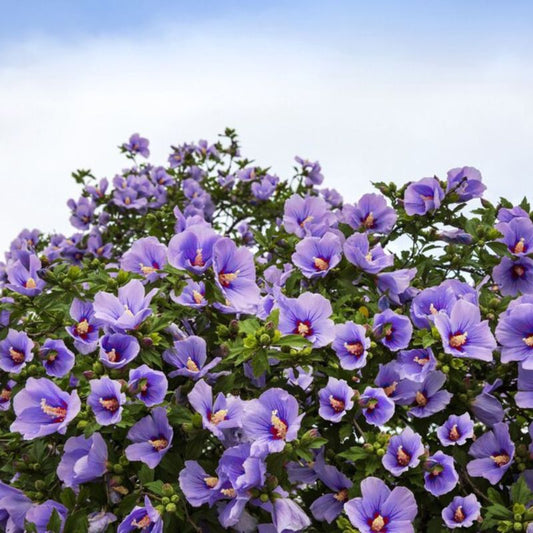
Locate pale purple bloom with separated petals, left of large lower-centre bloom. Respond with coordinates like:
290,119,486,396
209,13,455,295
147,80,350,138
187,379,243,441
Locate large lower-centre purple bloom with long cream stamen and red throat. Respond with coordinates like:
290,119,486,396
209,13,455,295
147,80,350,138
242,388,304,457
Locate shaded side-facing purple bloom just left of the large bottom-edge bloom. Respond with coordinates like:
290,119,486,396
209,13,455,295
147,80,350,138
309,463,352,524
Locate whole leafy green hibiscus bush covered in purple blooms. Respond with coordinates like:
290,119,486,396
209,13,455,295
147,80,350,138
0,129,533,533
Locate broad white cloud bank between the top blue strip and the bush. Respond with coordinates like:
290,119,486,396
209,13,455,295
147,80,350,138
0,25,533,254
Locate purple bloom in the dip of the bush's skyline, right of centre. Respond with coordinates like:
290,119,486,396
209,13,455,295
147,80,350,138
342,193,398,234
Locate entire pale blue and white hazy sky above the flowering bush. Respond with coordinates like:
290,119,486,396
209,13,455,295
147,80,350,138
0,0,533,250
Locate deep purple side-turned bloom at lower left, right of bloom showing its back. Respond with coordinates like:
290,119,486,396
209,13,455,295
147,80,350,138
125,407,174,468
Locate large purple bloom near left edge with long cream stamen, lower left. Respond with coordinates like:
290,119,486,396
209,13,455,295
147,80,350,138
10,378,81,440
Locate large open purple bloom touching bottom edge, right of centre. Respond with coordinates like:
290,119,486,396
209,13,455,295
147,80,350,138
344,477,418,533
